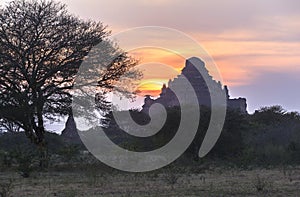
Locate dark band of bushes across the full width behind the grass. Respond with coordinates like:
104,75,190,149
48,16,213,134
0,106,300,176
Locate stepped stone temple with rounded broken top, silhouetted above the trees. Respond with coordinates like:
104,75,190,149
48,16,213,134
142,57,247,114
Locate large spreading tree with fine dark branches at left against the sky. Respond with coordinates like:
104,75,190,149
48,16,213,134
0,0,136,146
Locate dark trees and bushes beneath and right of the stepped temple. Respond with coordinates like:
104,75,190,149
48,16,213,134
106,106,300,166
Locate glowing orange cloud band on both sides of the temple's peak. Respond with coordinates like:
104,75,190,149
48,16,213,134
126,30,300,96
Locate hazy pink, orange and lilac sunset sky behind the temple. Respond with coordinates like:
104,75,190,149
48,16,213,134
0,0,300,112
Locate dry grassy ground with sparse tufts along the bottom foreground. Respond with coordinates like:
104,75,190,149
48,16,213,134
0,167,300,197
